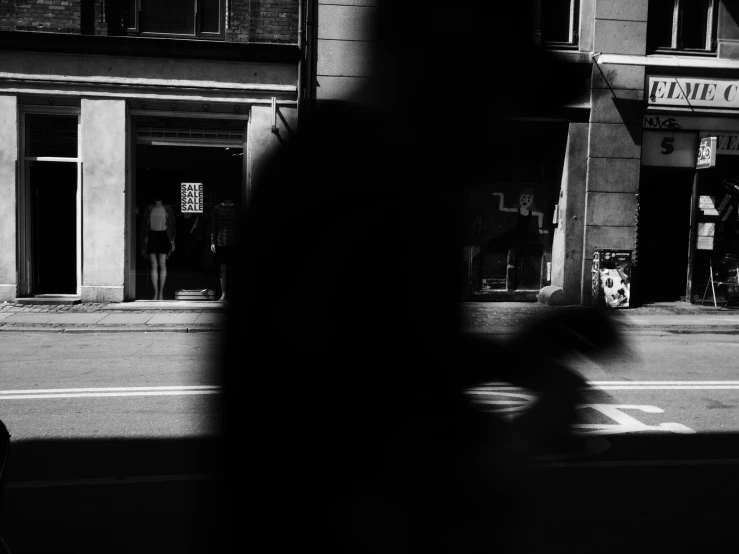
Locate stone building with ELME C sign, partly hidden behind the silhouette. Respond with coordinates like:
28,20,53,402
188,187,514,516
309,0,739,305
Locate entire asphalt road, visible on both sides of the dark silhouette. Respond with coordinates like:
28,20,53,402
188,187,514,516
0,332,739,553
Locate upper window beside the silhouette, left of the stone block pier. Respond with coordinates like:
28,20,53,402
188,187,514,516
534,0,580,48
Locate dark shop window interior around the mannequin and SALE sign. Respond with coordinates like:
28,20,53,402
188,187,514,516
136,144,243,300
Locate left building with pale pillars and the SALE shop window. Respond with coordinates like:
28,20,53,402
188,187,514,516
0,0,305,302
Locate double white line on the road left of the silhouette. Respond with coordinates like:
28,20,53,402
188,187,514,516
0,385,221,400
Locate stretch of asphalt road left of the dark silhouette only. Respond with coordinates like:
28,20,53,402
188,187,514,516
0,333,220,553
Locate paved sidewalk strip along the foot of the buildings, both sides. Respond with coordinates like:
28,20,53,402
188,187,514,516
0,300,739,335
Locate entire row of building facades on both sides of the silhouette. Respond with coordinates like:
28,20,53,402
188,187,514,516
0,0,739,304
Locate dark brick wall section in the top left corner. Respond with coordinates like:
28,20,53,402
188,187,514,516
11,0,81,33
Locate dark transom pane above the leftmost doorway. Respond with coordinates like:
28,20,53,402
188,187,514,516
25,114,77,158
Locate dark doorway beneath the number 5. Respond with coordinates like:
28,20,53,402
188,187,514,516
633,167,694,304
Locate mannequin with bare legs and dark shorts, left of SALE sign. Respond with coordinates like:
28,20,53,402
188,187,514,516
141,192,177,300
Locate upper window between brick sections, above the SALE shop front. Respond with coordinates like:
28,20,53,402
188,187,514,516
118,0,226,38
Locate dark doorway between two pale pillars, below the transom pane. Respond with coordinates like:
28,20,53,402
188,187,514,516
28,162,77,294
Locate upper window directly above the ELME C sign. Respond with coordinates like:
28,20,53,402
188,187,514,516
647,0,717,54
